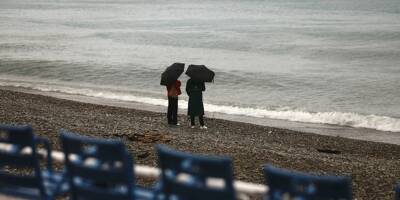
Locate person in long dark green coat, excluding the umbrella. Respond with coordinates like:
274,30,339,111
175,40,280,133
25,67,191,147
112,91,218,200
186,79,207,129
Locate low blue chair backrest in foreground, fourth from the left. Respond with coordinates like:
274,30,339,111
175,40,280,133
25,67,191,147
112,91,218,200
264,165,352,200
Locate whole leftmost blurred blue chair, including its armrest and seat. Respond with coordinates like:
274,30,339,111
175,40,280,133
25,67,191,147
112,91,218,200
0,125,67,200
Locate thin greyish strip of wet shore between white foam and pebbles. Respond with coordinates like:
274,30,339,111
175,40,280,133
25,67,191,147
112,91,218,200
0,86,400,145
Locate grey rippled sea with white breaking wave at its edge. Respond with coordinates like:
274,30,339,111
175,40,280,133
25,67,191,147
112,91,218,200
0,0,400,132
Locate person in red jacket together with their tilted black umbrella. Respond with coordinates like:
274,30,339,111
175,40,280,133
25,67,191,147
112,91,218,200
160,63,185,126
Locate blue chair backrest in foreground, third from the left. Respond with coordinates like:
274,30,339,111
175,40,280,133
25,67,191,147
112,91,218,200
157,145,236,200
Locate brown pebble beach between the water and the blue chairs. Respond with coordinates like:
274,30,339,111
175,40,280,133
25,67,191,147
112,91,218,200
0,88,400,199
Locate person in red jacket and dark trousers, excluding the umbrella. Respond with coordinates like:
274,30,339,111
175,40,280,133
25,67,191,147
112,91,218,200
167,80,182,126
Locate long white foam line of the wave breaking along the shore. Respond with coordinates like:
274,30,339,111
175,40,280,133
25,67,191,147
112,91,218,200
0,79,400,132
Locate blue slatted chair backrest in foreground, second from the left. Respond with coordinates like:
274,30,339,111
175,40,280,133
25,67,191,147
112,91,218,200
60,130,135,200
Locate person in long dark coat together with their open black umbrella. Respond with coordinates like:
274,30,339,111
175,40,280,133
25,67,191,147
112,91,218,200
186,65,214,129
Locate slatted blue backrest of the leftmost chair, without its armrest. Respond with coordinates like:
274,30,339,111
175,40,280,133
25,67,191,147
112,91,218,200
0,125,46,196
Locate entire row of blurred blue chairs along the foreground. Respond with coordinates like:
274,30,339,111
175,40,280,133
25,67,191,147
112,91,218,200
0,125,400,200
